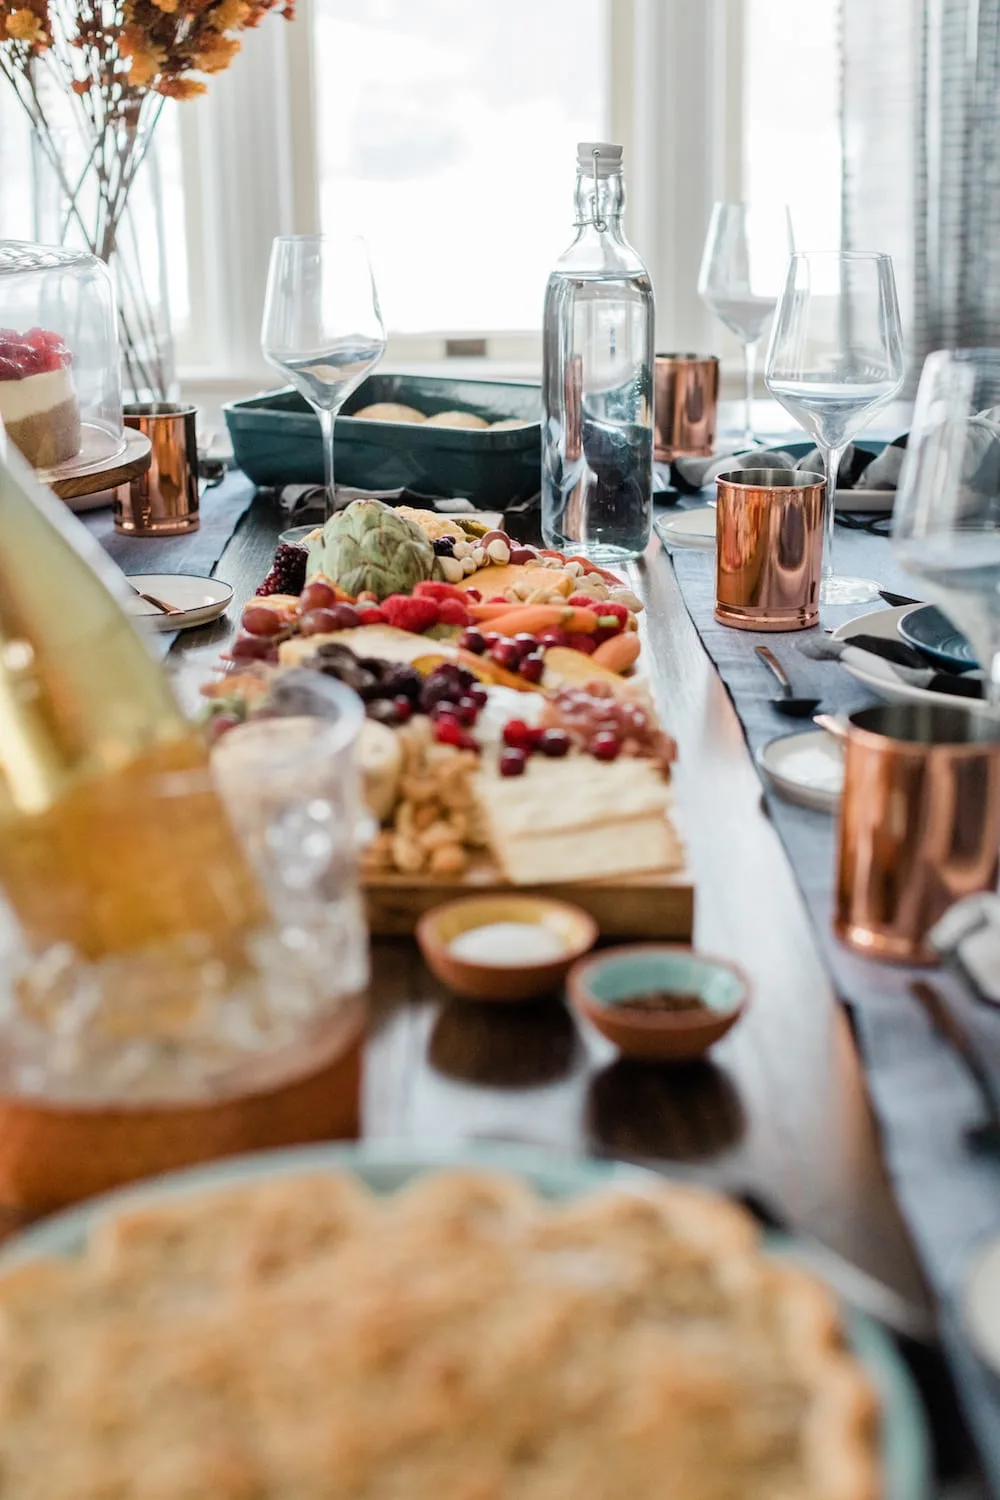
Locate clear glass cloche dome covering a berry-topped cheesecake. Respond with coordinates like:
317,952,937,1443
0,240,124,479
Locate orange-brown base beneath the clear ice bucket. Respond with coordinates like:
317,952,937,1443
0,999,364,1218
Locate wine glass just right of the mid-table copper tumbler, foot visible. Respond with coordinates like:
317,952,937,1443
765,251,903,605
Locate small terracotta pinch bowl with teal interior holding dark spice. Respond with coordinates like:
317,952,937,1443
567,944,750,1062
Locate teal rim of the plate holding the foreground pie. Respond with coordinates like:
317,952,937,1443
0,1142,931,1500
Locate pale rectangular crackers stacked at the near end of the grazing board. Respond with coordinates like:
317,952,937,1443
474,755,684,885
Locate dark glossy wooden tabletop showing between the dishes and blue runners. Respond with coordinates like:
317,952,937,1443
171,492,985,1500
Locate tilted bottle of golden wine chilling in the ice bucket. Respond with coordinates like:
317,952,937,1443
0,423,264,959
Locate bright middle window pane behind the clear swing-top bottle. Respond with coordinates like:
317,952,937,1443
315,0,610,335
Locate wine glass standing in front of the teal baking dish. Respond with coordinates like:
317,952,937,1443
261,234,385,518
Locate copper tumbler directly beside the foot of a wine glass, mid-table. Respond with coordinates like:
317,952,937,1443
715,470,826,630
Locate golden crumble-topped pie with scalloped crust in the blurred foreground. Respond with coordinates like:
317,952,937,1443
0,1172,879,1500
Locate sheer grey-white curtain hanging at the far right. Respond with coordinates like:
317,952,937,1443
841,0,1000,380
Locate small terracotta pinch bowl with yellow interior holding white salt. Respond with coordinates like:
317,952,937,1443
417,894,598,1001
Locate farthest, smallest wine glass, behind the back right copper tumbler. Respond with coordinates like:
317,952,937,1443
699,203,795,449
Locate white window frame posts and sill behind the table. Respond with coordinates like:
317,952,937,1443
180,0,745,405
